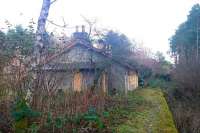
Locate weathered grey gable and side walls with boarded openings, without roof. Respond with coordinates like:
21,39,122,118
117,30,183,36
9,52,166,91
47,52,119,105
46,44,138,92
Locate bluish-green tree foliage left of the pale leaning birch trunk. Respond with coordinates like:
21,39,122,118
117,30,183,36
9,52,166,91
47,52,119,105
0,26,35,68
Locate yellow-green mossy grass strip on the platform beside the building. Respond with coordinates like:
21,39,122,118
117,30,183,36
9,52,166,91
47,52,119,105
110,88,178,133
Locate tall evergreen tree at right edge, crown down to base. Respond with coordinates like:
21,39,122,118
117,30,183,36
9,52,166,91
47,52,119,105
170,4,200,95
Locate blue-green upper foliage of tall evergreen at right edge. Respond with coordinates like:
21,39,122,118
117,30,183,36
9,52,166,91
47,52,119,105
170,4,200,58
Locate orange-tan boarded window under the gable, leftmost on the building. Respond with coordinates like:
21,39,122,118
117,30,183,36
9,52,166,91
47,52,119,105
73,72,83,92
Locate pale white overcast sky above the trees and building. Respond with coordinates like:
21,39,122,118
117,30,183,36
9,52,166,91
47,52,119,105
0,0,200,59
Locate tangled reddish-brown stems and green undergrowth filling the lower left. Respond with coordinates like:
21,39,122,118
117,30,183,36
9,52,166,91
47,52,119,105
0,61,115,133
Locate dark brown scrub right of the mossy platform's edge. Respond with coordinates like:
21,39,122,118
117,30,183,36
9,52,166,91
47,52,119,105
166,89,200,133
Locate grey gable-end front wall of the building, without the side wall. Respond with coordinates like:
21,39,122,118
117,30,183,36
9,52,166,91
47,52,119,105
46,44,109,90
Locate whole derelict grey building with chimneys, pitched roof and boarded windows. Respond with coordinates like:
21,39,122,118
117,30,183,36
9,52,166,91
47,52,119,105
40,26,138,92
